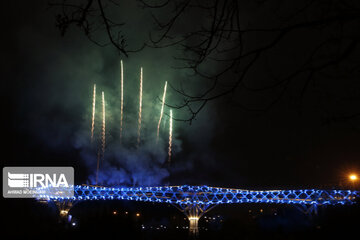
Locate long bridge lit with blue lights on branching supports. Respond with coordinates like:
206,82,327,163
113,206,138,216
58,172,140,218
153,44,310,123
40,185,359,235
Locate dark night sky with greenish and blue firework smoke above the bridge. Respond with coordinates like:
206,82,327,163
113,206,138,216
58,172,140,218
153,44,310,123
1,1,360,189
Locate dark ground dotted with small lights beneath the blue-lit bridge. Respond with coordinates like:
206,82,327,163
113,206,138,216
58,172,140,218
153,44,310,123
1,199,360,239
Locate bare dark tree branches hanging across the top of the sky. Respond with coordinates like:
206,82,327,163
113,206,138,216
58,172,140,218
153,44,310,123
51,0,360,123
